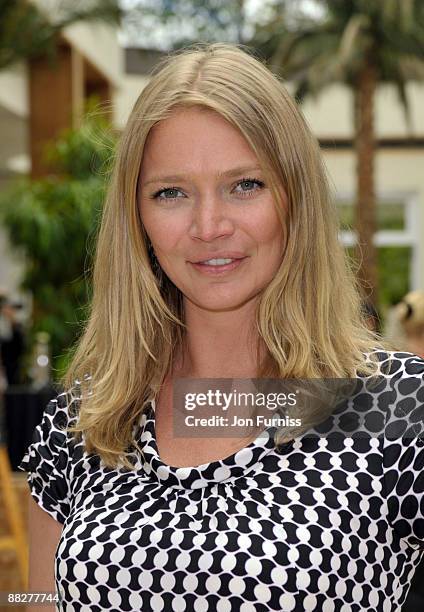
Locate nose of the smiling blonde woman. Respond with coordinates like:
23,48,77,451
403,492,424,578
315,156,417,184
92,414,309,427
190,196,235,242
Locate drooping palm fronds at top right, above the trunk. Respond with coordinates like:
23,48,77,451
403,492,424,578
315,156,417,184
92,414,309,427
251,0,424,107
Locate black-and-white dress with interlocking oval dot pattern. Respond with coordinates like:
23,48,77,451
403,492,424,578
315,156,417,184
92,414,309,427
19,351,424,612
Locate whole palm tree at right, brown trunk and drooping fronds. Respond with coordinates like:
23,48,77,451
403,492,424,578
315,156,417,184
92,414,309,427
252,0,424,307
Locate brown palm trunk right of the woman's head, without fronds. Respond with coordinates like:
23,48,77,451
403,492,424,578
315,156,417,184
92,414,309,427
354,62,378,307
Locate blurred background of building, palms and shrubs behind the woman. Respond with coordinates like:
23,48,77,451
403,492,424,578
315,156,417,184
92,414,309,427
0,0,424,612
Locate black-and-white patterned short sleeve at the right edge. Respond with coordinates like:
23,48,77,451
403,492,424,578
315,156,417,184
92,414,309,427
383,354,424,550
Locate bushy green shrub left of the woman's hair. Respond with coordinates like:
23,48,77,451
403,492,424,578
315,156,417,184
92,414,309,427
0,113,115,374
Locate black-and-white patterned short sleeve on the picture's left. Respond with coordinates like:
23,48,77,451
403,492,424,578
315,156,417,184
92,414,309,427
18,393,75,524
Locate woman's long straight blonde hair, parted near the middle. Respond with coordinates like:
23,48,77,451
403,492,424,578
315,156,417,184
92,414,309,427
62,43,394,468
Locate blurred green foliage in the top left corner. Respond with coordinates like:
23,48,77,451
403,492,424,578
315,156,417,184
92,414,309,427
0,0,122,70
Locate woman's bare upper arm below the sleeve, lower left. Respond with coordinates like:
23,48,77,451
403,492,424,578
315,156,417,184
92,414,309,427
27,495,63,612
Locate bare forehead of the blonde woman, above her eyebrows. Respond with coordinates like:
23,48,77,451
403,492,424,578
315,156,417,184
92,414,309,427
141,107,258,175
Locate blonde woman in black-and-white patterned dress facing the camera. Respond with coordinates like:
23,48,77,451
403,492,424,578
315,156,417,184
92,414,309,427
21,44,424,612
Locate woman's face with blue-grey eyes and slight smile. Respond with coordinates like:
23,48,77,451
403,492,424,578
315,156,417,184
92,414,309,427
139,108,286,311
